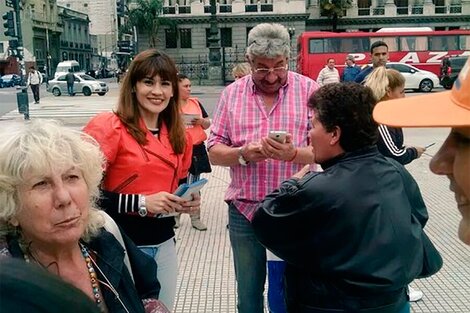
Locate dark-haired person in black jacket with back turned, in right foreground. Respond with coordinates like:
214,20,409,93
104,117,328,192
252,83,442,313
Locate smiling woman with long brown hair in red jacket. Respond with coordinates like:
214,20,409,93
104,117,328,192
84,49,200,310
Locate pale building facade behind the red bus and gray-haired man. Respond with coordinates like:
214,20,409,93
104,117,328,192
131,0,470,83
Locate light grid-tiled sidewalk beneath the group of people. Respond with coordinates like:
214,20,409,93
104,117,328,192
175,148,470,313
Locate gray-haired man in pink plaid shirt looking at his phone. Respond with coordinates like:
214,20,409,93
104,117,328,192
208,24,318,313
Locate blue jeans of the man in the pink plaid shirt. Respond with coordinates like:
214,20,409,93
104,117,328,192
228,204,266,313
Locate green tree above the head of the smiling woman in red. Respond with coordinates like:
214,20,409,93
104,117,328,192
119,0,176,48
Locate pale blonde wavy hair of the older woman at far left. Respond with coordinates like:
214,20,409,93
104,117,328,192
0,119,105,241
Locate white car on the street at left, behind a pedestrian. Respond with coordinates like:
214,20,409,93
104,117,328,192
47,74,109,97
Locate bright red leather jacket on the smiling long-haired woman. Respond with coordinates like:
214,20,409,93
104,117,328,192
84,112,192,195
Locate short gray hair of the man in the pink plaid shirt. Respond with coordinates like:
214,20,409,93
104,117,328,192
246,23,290,59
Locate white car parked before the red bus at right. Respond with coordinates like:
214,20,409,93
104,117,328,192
387,62,439,92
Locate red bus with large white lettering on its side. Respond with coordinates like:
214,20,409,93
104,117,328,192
297,28,470,79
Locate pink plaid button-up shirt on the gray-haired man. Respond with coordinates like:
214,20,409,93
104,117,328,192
207,72,318,221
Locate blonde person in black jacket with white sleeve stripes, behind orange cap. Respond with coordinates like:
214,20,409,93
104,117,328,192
364,66,426,165
